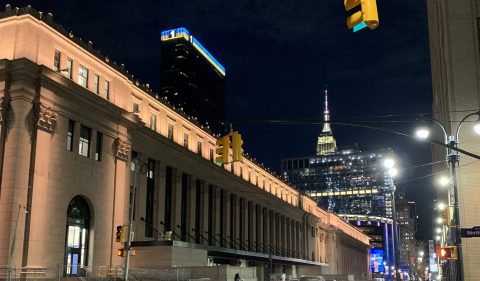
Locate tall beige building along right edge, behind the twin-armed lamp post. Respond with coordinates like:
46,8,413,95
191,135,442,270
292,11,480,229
427,0,480,281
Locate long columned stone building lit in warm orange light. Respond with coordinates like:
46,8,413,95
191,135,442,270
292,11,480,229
0,5,369,280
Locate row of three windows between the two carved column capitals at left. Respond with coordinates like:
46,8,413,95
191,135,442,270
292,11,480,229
67,119,103,161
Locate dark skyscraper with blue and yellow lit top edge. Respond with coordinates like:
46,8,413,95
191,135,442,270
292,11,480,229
160,28,225,134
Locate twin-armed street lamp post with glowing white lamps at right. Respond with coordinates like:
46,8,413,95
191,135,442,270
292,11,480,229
416,111,480,281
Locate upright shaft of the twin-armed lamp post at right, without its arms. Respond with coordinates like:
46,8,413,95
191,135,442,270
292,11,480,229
447,137,464,281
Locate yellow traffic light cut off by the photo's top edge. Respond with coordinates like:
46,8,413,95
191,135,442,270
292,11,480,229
343,0,378,31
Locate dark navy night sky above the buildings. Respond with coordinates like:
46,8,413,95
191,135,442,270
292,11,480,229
15,0,433,239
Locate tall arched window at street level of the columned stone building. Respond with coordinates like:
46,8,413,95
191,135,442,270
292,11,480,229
65,195,91,276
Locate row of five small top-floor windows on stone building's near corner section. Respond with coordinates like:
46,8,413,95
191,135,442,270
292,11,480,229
53,50,110,100
